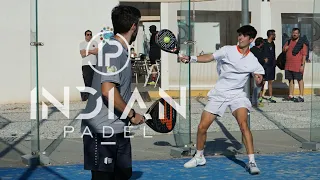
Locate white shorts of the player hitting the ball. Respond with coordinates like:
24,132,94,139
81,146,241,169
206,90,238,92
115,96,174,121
204,89,252,117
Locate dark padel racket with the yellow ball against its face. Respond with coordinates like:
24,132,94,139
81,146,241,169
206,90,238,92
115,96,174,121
155,29,190,63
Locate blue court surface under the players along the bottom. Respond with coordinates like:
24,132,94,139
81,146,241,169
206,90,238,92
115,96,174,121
0,152,320,180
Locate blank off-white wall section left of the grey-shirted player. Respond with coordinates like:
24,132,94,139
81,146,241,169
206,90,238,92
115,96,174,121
0,0,119,104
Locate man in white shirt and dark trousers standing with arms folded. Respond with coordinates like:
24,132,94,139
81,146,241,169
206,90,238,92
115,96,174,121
80,30,98,101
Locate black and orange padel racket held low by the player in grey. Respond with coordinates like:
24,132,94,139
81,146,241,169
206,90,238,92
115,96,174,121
129,98,177,133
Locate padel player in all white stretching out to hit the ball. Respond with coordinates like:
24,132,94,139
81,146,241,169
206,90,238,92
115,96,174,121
180,25,264,174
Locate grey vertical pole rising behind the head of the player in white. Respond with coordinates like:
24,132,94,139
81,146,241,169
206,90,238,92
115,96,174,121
241,0,251,148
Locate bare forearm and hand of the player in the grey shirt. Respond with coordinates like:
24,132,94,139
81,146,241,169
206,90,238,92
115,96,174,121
101,82,143,124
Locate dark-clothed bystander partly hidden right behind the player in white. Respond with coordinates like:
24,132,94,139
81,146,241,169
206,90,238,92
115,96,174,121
250,37,267,107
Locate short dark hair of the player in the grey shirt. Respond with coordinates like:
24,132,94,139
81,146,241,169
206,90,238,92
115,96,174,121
111,5,141,34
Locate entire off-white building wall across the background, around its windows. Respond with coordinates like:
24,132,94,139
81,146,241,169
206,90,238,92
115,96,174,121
0,0,313,104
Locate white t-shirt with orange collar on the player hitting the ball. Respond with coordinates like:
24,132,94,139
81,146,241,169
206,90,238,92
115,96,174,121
208,46,265,98
